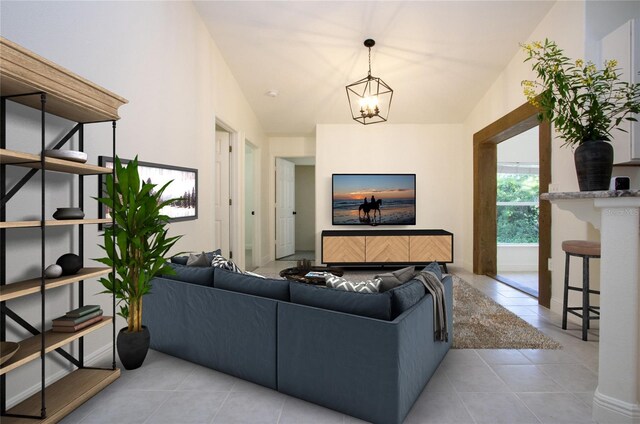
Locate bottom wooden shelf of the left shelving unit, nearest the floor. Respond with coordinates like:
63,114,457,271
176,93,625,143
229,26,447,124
2,368,120,424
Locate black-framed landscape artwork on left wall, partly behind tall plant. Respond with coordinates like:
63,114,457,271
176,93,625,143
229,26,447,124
98,156,198,221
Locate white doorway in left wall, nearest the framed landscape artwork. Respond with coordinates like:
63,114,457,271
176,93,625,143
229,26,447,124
214,122,237,259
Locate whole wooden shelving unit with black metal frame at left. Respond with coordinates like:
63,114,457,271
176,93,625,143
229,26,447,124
0,37,127,424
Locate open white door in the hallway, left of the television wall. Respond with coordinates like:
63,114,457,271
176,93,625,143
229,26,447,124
276,158,296,259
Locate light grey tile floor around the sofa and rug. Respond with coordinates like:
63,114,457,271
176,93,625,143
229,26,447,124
62,261,598,424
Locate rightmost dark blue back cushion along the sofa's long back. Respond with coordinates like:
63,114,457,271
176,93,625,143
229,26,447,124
289,281,391,320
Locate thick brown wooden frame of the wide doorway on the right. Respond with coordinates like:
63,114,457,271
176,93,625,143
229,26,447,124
473,103,551,308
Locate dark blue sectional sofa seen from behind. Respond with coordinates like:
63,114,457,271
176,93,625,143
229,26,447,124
143,265,453,424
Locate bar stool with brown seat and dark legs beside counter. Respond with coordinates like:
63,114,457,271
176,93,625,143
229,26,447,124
562,240,600,341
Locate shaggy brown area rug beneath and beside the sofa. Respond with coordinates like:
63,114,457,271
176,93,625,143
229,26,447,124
256,269,562,349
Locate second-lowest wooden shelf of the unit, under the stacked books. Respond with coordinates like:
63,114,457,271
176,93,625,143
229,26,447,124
0,316,113,376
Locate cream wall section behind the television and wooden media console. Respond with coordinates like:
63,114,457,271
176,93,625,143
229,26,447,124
316,124,464,263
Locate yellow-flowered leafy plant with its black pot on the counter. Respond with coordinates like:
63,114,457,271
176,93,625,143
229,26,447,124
522,40,640,191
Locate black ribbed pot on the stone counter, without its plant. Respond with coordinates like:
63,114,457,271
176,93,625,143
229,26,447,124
574,141,613,191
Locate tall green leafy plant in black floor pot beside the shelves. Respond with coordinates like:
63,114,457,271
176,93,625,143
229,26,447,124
97,156,181,369
